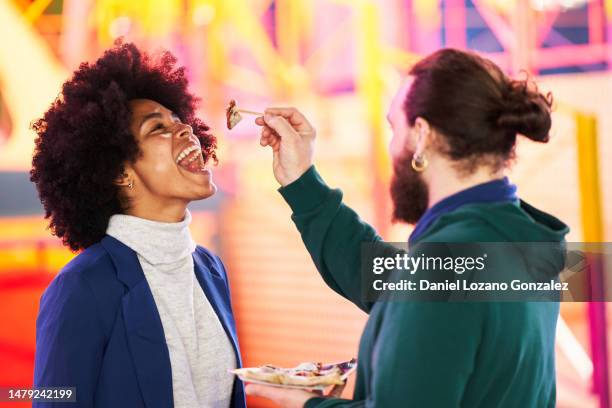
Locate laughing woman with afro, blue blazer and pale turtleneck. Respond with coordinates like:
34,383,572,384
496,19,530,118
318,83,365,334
31,43,245,408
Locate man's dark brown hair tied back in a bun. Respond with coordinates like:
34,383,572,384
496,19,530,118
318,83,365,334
404,49,552,172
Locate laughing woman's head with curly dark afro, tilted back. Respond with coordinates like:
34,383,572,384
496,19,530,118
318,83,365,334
31,44,217,250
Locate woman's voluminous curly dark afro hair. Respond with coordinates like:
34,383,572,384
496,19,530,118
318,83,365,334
30,41,217,251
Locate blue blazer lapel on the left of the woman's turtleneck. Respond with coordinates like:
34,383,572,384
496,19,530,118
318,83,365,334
101,235,174,408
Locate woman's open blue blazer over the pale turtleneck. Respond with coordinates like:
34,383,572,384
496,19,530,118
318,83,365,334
33,236,246,408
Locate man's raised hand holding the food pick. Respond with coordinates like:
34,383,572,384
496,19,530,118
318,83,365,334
255,108,316,187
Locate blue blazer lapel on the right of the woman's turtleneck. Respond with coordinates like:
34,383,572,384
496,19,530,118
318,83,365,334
193,251,242,367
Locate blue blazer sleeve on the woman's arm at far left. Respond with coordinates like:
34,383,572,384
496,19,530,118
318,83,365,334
33,271,105,408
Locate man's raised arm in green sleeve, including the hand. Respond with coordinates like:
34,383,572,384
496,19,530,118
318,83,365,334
255,108,397,312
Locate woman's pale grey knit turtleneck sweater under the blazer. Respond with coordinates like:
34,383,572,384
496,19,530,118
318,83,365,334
106,210,236,408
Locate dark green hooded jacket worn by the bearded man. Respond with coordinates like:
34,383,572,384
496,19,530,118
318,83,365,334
279,167,568,408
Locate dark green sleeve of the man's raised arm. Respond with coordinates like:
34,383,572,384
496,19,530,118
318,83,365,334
279,166,398,313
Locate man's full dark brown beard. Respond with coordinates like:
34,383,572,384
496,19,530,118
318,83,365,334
391,149,429,224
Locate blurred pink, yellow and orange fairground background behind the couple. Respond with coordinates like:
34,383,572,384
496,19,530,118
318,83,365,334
0,0,612,408
